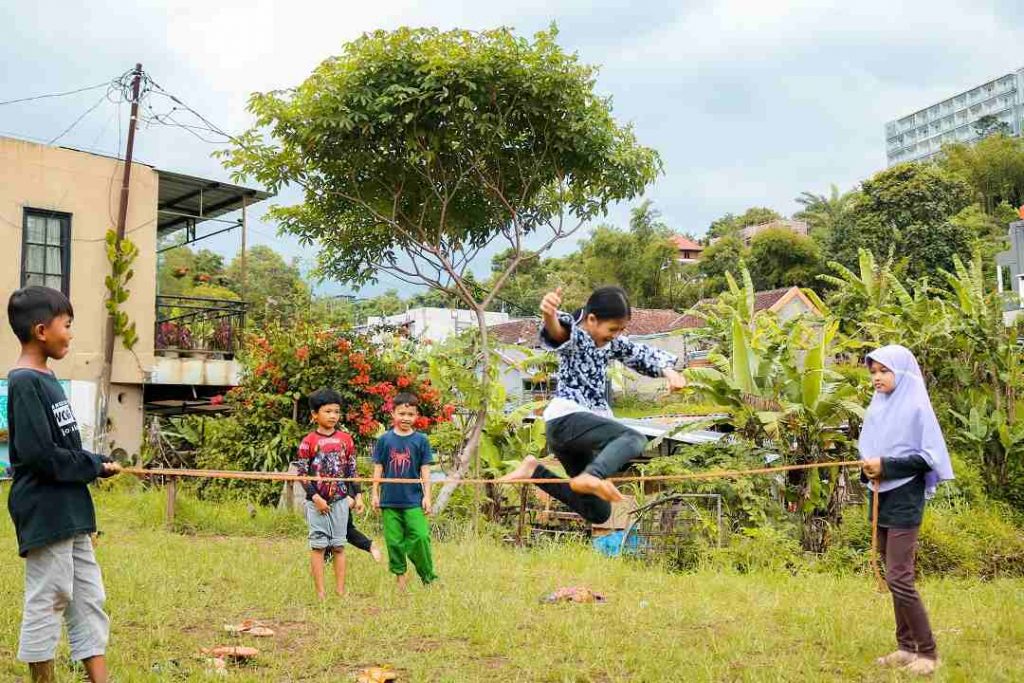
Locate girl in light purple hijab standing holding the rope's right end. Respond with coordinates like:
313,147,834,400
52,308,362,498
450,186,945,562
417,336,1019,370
858,345,953,676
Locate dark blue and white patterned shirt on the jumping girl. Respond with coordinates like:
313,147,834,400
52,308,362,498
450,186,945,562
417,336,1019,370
541,313,678,420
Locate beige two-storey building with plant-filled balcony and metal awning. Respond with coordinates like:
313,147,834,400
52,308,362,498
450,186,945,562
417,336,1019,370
0,137,268,459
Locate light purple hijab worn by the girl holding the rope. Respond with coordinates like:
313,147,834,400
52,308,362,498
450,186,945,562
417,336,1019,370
857,344,953,498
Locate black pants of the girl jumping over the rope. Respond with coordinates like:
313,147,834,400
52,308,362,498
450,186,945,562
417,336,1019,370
534,413,647,524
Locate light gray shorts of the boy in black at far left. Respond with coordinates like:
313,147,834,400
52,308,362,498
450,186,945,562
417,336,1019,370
17,535,111,664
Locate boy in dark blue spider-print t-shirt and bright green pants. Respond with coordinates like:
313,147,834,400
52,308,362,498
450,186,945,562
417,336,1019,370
373,392,437,591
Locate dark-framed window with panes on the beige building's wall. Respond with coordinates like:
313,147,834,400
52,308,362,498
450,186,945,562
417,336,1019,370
22,209,71,295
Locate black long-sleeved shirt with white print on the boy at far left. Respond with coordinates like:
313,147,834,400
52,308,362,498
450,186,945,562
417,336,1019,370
7,368,105,557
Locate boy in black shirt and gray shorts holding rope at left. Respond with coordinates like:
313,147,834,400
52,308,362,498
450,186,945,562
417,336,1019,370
7,287,121,683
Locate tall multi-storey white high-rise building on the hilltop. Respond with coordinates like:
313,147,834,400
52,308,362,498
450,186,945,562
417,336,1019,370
886,69,1024,166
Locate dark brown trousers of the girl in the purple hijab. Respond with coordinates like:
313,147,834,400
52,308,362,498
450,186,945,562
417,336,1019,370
879,527,938,659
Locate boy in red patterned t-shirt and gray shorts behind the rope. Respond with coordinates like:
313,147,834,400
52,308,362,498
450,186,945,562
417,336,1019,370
297,389,381,600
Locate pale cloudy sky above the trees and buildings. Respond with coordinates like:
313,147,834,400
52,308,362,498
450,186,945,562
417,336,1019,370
0,0,1024,294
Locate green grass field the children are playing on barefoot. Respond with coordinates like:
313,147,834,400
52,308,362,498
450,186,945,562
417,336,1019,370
0,483,1024,682
